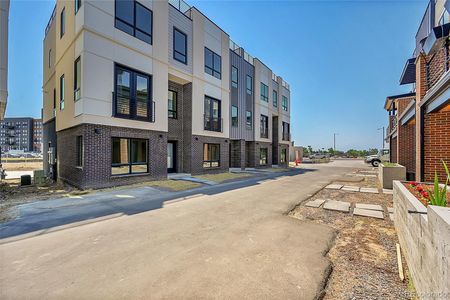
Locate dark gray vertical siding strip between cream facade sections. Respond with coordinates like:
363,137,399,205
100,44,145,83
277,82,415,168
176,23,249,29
230,50,255,141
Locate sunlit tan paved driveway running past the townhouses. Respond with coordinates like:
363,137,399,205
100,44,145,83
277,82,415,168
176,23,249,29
0,161,366,299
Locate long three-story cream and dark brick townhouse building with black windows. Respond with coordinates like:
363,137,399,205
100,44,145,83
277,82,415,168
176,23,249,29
43,0,290,188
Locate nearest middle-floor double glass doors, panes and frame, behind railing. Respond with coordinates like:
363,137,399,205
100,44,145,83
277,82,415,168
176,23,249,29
114,65,153,121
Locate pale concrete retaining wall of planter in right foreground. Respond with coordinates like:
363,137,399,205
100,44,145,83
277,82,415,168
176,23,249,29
394,181,450,299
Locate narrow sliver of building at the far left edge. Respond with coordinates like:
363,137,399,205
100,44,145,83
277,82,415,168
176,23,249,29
0,0,9,121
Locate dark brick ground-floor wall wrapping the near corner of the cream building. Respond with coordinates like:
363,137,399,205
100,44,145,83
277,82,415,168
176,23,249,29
57,124,167,189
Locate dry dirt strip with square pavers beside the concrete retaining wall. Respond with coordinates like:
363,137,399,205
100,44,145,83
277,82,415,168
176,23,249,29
290,188,412,299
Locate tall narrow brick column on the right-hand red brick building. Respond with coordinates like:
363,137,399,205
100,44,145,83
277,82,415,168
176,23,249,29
416,53,427,181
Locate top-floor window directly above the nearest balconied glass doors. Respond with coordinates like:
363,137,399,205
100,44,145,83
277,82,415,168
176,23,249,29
115,0,153,44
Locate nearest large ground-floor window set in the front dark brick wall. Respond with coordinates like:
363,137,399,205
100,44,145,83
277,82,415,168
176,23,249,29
111,138,148,175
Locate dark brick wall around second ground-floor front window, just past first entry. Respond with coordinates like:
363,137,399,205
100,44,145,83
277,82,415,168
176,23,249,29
191,135,230,175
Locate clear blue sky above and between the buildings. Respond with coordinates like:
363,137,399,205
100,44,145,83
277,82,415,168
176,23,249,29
6,0,428,150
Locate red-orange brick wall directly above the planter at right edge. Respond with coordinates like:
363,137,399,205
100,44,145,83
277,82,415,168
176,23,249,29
423,104,450,182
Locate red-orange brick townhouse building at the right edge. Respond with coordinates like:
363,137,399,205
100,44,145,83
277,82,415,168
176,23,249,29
385,0,450,181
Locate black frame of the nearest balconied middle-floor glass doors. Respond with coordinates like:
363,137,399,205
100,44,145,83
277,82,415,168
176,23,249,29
113,63,154,122
